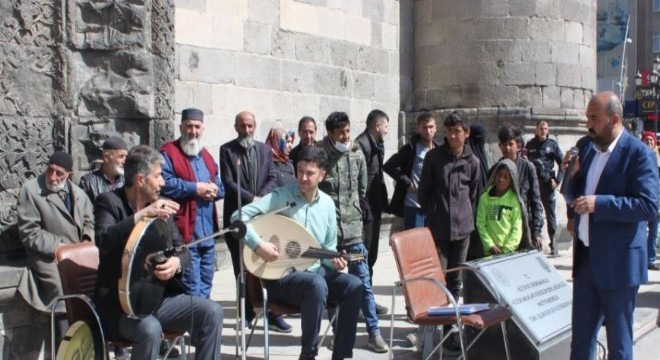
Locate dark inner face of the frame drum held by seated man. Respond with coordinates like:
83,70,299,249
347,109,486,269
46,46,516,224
128,219,172,317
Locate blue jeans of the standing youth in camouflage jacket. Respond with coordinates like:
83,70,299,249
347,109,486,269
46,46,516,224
337,243,380,335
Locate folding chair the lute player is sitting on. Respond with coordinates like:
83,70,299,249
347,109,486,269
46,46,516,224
236,271,338,360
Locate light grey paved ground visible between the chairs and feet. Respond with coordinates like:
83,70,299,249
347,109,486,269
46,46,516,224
191,238,660,360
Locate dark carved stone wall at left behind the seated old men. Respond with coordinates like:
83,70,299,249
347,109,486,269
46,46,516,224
0,0,174,359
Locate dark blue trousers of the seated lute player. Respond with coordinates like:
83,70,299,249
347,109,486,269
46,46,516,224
264,263,369,359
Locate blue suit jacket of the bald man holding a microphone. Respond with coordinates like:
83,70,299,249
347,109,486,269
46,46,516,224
569,131,658,289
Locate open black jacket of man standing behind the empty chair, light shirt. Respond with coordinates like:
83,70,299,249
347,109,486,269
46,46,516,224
383,134,440,217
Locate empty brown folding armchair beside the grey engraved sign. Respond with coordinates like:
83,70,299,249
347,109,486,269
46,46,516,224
390,228,511,360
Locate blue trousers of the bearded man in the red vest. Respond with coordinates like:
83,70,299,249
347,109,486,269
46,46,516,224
181,239,215,299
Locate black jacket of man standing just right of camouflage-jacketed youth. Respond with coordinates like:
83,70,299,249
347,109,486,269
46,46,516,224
355,130,389,213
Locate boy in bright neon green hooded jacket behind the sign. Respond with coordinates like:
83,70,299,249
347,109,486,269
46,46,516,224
477,159,526,255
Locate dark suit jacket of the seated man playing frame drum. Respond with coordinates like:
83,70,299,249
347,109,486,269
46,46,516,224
94,186,190,340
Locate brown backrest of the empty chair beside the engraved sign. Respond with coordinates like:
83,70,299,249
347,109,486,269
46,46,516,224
390,227,449,321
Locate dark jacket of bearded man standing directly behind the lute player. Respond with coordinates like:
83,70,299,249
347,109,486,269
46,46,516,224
220,139,277,227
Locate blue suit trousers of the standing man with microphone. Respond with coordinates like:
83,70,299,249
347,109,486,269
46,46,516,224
571,241,639,360
